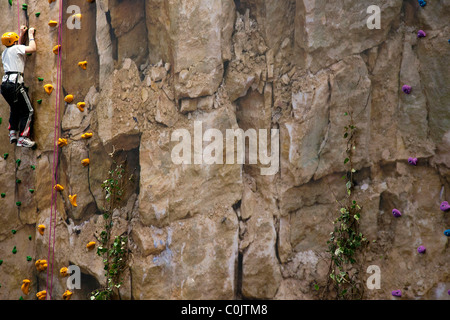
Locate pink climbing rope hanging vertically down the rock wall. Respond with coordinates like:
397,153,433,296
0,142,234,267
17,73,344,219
46,0,63,300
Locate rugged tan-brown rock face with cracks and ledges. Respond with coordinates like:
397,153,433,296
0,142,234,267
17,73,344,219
0,0,450,299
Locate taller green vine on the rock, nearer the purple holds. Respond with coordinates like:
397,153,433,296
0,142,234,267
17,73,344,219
322,112,367,299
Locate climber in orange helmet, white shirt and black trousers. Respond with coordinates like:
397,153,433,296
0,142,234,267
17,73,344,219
1,26,36,148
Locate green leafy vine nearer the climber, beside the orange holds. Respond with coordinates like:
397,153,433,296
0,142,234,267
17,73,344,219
90,161,132,300
